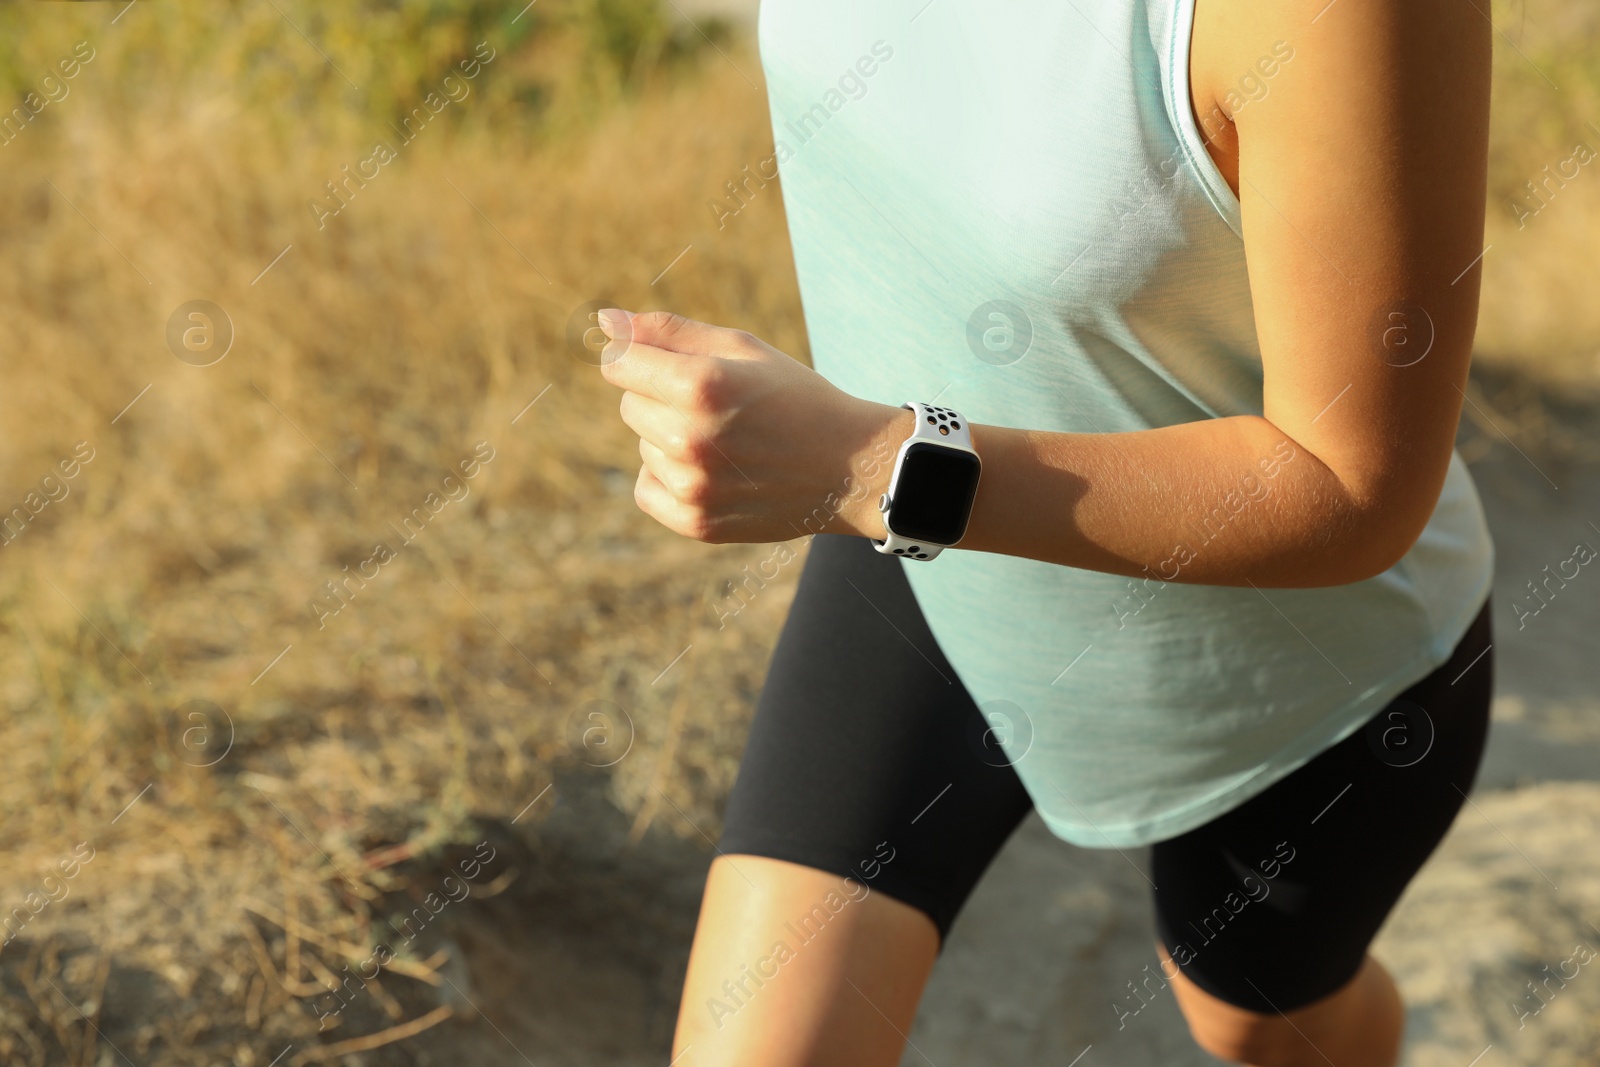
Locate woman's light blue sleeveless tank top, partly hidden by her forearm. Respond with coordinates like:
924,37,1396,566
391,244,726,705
758,0,1493,848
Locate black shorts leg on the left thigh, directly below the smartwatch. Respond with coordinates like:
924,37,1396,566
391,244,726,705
720,534,1032,944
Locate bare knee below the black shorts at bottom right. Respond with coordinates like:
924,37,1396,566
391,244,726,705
1155,942,1405,1067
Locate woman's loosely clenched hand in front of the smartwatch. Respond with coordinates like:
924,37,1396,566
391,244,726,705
600,309,915,544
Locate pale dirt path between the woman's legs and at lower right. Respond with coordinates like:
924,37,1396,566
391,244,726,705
901,422,1600,1067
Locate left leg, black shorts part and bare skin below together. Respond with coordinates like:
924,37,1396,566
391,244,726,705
672,534,1032,1067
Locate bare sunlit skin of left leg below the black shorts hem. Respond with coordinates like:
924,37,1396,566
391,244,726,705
672,856,939,1067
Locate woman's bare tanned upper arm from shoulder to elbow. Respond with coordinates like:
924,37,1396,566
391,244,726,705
1195,0,1491,558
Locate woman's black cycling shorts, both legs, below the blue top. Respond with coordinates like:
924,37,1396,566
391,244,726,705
720,534,1493,1013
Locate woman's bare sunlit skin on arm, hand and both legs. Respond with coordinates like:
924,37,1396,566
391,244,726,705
602,0,1491,1067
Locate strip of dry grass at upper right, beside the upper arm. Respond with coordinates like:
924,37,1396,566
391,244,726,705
1462,0,1600,462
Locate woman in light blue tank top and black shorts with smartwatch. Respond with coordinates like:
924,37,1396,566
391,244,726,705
603,0,1493,1067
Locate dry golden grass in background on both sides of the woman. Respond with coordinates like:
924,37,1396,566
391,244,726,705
0,0,1600,1064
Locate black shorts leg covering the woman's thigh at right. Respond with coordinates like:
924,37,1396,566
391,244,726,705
1152,605,1493,1014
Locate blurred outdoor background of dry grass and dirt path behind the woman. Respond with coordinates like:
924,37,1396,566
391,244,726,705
0,0,1600,1067
